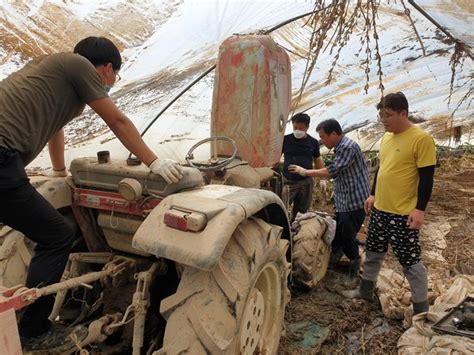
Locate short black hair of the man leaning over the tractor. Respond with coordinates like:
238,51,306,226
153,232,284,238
74,36,122,71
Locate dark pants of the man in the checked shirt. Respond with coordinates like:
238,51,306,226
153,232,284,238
332,209,365,260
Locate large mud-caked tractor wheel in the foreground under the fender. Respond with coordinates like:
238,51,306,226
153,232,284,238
155,218,290,355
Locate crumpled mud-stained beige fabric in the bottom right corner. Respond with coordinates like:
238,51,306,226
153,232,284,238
397,275,474,355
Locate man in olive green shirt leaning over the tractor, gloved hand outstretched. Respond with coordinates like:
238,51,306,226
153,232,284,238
0,37,182,349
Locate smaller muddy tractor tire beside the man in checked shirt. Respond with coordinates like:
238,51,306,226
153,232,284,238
293,216,331,290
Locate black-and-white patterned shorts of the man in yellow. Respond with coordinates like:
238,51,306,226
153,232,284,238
366,208,421,266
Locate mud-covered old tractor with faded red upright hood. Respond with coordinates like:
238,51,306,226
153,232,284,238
0,35,329,354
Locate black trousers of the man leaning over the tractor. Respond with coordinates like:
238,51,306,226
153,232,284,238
0,147,75,337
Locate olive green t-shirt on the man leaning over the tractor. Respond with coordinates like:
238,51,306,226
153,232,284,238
0,53,108,166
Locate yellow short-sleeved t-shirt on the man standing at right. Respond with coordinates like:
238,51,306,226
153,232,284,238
375,126,436,215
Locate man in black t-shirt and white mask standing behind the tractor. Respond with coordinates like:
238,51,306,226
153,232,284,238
283,113,324,221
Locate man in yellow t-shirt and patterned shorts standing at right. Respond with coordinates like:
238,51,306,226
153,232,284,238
345,92,436,314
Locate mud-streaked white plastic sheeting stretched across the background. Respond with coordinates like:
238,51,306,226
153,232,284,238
0,0,474,167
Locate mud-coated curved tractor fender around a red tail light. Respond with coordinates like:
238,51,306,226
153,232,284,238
132,185,288,271
